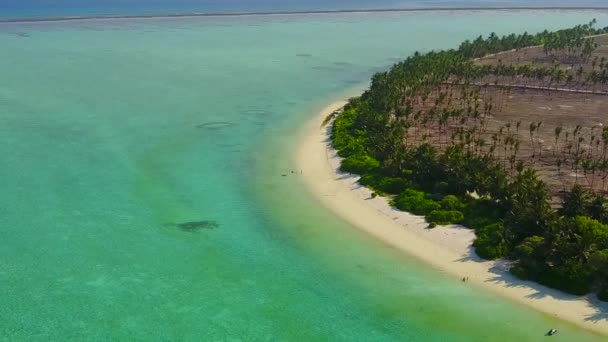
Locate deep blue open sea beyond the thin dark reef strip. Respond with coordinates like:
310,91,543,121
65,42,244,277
0,0,606,19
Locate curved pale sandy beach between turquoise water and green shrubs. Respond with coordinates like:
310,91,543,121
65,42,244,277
296,100,608,335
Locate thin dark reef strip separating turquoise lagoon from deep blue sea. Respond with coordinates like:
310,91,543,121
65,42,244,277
0,6,608,24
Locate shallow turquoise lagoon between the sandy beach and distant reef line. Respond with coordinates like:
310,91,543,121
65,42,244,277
0,12,608,341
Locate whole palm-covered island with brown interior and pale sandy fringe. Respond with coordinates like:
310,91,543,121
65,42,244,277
300,20,608,331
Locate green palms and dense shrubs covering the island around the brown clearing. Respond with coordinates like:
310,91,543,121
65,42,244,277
332,21,608,299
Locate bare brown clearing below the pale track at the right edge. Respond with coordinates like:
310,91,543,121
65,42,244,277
488,90,608,199
